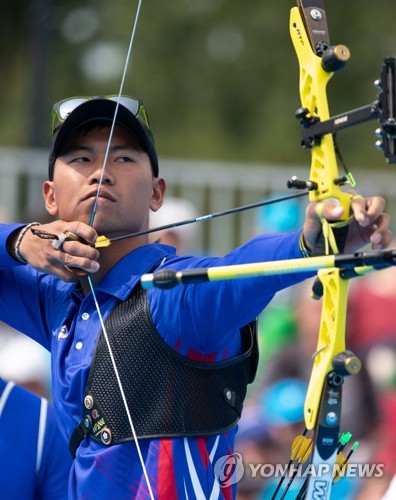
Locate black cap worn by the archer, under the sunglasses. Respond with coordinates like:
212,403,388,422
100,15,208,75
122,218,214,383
48,97,159,180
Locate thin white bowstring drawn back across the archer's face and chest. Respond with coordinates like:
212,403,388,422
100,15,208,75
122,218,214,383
88,0,154,500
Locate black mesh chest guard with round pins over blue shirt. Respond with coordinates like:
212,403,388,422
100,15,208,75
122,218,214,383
69,287,258,456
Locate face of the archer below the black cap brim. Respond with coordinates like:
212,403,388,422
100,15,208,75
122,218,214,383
44,126,165,237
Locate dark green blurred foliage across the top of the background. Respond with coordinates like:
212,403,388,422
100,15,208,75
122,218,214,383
0,0,396,168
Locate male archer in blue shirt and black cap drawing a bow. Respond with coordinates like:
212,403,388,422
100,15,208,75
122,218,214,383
0,96,392,499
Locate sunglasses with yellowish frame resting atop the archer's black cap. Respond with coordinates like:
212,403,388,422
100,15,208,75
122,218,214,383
51,95,151,136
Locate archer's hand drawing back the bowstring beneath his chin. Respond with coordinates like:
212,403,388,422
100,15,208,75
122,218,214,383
8,221,100,282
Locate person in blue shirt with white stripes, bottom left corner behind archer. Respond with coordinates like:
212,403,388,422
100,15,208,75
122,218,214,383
0,378,72,500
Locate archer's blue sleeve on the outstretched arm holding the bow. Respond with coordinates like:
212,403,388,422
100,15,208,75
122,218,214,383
149,231,312,354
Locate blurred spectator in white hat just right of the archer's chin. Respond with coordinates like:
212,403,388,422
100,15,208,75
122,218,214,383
150,198,203,255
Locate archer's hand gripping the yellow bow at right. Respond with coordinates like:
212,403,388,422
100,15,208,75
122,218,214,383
303,192,392,253
